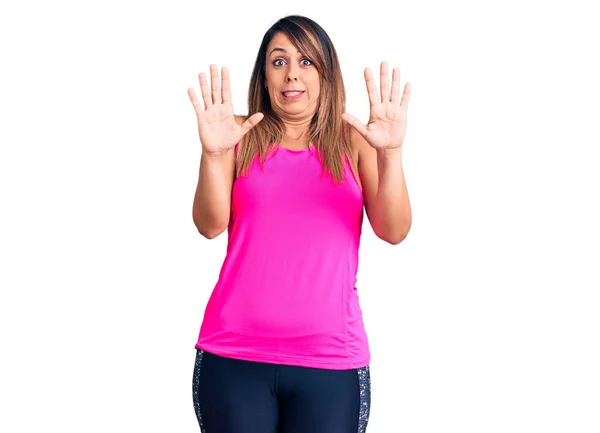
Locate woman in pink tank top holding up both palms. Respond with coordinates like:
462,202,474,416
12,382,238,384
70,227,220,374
188,16,411,433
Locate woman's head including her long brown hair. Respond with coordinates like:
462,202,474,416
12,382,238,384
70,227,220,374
236,15,356,181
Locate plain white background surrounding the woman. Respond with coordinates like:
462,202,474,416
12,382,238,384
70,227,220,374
0,0,600,433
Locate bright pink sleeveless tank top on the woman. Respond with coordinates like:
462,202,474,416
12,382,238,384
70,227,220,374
195,142,370,370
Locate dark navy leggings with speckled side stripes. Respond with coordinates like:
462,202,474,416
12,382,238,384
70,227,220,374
192,349,371,433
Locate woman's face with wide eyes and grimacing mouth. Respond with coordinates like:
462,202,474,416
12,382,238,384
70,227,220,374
265,32,320,118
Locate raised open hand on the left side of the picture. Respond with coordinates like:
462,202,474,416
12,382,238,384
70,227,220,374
188,65,264,155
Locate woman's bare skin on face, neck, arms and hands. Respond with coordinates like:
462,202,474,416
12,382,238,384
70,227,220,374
188,33,412,245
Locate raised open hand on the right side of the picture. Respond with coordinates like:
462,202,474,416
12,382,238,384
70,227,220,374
342,62,411,150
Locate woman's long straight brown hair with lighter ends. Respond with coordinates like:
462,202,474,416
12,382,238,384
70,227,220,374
236,15,358,183
